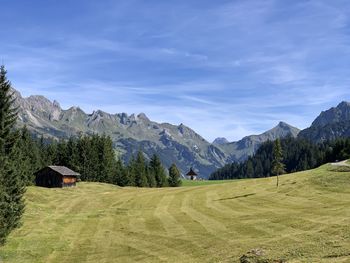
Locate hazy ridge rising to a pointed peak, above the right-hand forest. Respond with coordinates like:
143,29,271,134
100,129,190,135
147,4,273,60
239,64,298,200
217,122,300,161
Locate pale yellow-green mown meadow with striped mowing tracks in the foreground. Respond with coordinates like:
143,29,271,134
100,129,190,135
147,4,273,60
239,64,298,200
0,165,350,263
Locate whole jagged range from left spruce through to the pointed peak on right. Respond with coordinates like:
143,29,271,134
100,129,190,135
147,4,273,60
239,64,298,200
14,90,299,178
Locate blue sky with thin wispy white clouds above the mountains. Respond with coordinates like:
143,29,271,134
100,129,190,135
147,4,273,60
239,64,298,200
0,0,350,141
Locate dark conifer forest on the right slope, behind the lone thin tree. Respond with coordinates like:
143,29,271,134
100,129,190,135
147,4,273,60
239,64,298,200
209,137,350,180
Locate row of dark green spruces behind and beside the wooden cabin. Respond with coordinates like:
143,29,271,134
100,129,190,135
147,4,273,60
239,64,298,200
18,134,172,187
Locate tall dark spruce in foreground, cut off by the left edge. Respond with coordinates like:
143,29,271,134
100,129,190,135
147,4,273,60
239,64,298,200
0,66,25,244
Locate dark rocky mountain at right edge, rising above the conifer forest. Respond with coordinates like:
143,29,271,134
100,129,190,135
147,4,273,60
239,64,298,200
298,101,350,143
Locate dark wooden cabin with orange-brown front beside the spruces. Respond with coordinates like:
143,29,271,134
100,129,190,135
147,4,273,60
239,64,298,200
35,166,80,188
